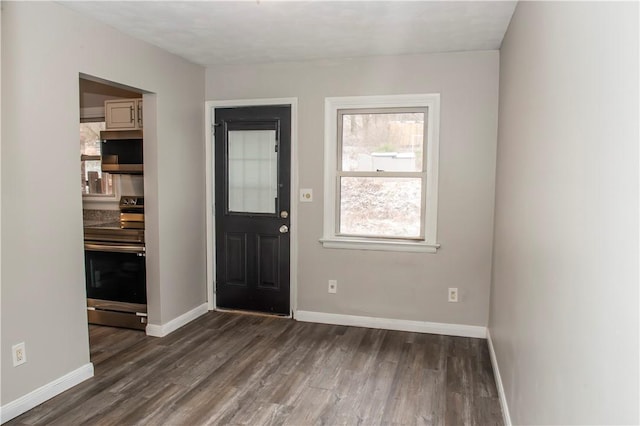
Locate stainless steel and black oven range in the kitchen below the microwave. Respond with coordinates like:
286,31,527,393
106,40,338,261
84,197,147,330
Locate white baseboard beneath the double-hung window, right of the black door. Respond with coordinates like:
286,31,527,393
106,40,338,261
294,311,487,339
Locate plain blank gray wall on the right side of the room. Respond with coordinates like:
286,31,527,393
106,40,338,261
490,2,639,424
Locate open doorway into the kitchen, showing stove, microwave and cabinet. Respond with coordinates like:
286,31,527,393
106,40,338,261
78,74,156,364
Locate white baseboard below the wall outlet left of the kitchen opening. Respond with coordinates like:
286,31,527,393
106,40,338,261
0,363,93,423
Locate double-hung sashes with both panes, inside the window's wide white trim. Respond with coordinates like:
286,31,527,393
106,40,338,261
336,108,427,240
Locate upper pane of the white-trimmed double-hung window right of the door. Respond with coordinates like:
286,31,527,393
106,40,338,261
342,112,425,172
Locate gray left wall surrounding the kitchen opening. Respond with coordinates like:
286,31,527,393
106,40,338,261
1,1,206,405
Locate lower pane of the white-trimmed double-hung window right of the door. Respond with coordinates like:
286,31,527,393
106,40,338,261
339,177,422,238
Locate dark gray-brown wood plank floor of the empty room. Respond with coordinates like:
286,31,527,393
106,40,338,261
7,312,502,425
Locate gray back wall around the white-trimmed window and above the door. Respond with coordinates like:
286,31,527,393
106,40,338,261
206,51,499,326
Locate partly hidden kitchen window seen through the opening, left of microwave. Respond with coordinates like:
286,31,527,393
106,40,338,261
80,121,116,200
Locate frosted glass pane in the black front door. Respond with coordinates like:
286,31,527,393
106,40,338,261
228,130,278,213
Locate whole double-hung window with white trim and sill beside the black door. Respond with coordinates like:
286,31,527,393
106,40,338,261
321,94,439,252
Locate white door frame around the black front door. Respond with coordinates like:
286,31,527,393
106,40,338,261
204,98,298,317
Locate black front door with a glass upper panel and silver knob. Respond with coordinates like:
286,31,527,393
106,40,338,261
215,105,291,315
